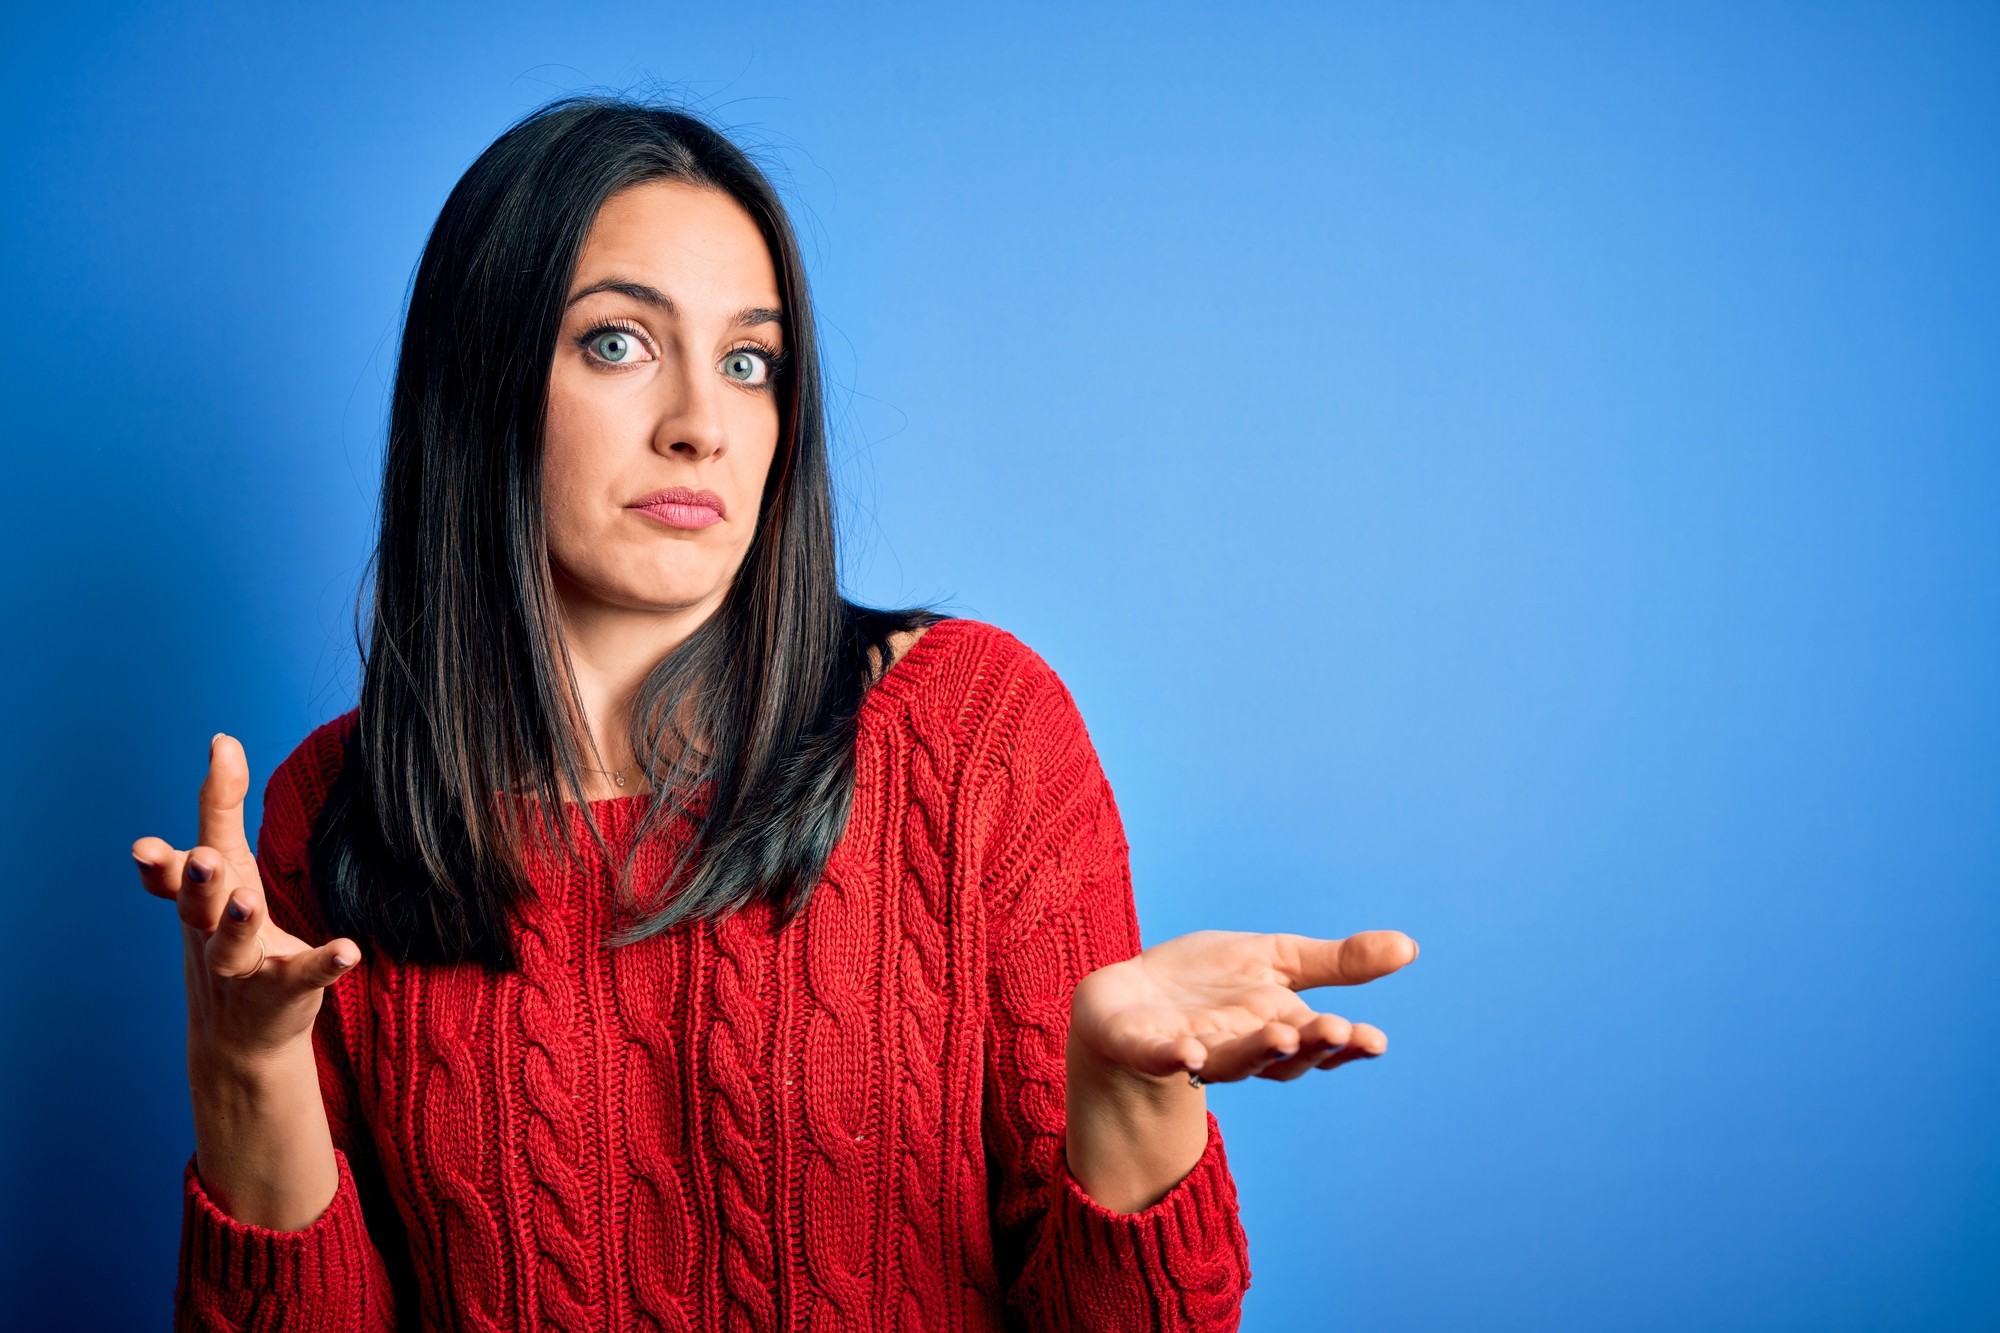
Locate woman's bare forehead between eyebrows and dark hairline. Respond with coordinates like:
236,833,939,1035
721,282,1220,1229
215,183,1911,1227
570,180,778,298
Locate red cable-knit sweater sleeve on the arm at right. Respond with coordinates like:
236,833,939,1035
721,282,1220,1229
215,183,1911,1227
974,652,1250,1333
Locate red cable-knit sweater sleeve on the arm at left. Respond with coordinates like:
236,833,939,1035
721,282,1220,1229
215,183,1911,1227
174,719,408,1333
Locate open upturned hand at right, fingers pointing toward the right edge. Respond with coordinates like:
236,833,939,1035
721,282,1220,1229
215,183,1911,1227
1070,931,1416,1083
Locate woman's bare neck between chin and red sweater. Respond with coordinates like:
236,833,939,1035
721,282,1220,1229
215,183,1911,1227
558,586,722,801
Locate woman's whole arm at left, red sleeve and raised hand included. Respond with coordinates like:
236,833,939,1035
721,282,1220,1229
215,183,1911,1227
132,737,394,1329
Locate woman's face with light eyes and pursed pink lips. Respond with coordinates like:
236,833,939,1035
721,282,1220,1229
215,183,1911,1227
542,180,784,618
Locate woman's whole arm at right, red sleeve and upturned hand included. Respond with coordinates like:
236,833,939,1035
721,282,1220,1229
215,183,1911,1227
972,640,1416,1331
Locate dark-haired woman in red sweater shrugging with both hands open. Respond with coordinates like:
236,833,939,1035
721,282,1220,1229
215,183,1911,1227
132,100,1416,1329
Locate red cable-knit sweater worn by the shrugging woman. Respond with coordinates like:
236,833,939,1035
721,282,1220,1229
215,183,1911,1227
178,620,1250,1333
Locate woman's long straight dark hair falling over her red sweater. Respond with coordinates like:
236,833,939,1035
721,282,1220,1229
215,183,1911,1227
312,98,930,971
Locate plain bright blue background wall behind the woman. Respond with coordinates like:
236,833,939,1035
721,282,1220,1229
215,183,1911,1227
0,2,2000,1331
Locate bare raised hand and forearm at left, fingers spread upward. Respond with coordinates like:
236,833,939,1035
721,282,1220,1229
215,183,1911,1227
132,735,362,1231
